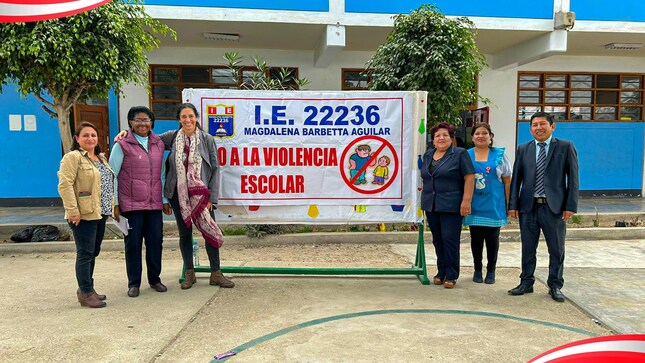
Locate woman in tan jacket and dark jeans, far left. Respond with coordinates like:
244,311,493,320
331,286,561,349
58,122,114,308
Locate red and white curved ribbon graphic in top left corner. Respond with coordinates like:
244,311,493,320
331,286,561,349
0,0,111,23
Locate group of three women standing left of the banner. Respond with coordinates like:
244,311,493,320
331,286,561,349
58,103,235,308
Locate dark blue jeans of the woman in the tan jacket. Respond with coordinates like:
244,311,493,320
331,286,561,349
68,216,108,294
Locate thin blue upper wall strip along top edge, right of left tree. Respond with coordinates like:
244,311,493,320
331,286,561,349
145,0,329,11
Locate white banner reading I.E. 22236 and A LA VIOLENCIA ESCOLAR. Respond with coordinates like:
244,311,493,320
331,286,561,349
183,89,426,223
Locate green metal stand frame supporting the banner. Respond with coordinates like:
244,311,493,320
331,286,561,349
179,223,430,285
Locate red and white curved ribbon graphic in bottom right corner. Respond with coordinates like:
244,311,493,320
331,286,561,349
528,334,645,363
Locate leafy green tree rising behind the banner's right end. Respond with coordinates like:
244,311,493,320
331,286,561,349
367,5,486,125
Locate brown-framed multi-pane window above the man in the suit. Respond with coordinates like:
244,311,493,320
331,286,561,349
517,72,644,121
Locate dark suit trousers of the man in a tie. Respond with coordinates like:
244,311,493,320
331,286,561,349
520,203,566,288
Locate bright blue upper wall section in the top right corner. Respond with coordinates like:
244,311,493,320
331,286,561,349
570,0,645,22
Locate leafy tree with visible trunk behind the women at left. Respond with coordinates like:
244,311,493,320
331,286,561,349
0,0,176,150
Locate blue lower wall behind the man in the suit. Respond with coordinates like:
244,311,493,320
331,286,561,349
517,122,645,191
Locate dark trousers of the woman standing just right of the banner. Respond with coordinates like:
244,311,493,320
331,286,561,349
426,212,464,280
